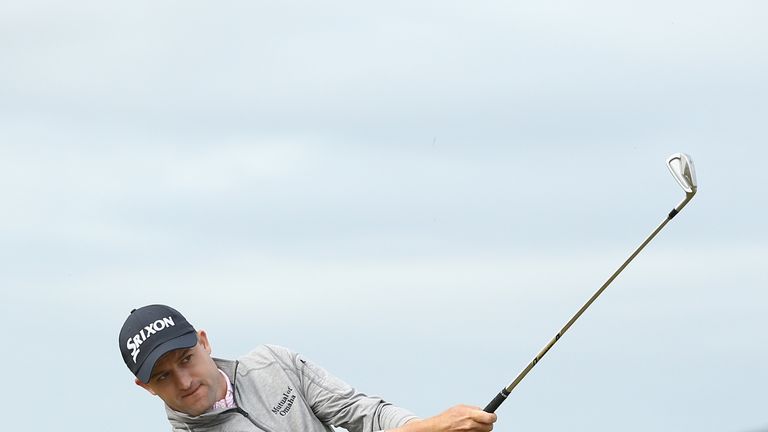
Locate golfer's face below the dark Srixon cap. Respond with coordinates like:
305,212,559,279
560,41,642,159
136,330,227,416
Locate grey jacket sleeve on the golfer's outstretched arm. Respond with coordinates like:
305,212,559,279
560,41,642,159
280,348,417,432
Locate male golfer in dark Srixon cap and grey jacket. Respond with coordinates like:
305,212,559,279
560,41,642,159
119,305,496,432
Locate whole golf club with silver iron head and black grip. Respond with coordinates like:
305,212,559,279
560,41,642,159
484,153,697,413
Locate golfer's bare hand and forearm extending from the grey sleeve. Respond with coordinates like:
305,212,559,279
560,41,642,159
388,405,496,432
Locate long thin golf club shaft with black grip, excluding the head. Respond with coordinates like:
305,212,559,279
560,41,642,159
484,194,693,413
